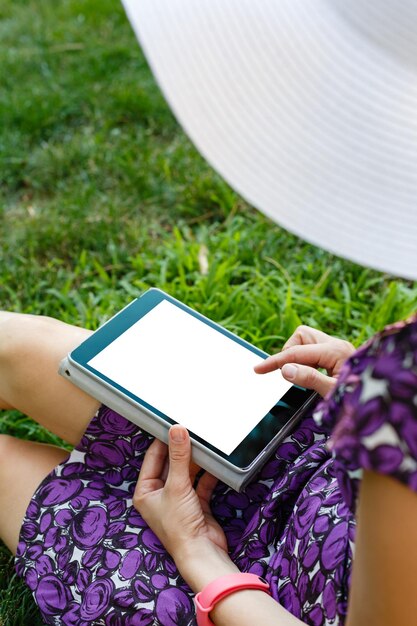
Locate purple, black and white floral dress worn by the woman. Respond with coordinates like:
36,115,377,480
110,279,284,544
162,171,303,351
16,319,417,626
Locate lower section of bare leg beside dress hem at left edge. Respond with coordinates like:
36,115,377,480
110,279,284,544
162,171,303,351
0,435,68,554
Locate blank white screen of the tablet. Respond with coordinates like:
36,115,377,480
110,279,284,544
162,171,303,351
88,300,291,454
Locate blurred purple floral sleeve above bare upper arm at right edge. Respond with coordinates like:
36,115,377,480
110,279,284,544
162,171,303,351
315,316,417,510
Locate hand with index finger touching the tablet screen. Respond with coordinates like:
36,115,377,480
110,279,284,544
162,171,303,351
255,326,355,396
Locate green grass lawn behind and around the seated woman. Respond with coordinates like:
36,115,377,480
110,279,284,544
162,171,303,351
0,0,417,626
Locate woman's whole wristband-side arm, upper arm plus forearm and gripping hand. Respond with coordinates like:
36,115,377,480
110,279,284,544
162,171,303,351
134,426,417,626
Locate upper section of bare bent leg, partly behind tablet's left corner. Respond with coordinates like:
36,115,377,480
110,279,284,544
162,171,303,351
0,312,99,445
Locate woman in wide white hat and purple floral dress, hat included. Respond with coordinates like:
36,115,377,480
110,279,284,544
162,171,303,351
4,0,417,626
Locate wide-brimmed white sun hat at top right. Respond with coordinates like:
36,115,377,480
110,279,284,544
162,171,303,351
123,0,417,279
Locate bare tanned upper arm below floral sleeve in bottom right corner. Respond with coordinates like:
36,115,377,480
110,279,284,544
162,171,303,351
346,472,417,626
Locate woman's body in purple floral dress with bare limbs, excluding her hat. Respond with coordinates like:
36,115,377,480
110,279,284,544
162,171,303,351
0,313,417,626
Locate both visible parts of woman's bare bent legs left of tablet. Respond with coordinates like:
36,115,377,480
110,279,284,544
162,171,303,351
0,311,104,552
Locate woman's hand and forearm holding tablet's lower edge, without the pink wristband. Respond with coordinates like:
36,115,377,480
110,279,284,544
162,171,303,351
133,425,303,626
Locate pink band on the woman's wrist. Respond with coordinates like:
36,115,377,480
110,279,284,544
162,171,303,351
194,572,271,626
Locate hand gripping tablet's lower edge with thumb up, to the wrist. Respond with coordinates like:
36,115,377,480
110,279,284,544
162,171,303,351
133,424,227,562
